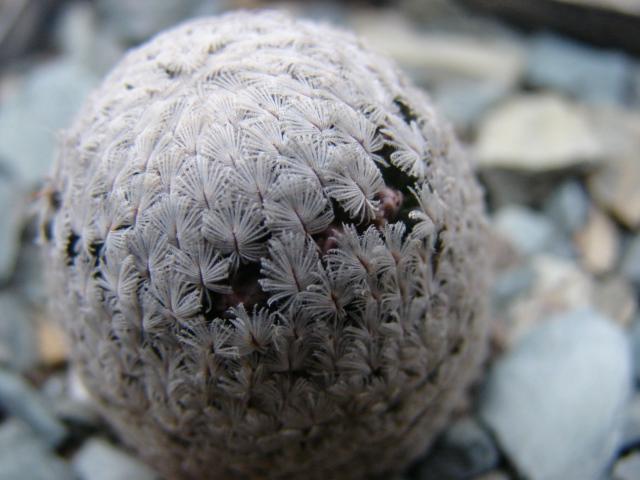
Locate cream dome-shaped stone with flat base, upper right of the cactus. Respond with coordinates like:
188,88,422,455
475,94,602,172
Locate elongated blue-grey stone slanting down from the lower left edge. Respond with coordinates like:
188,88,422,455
0,368,67,447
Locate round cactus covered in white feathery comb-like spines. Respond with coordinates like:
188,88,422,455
42,12,487,479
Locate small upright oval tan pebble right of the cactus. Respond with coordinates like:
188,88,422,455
575,208,619,274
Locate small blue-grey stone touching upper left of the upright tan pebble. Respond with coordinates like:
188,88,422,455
544,180,590,234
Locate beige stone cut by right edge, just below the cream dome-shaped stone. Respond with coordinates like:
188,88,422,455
588,152,640,229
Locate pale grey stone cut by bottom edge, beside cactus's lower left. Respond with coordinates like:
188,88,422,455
72,438,159,480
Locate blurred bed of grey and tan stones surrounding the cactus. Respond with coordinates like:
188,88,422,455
0,0,640,480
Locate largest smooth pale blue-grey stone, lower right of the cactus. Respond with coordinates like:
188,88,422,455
480,309,631,480
